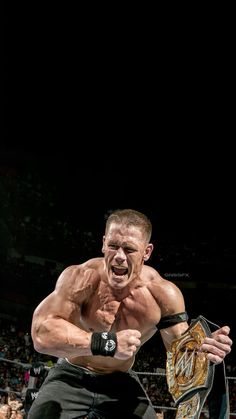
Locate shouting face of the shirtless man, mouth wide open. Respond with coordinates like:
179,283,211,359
102,223,153,289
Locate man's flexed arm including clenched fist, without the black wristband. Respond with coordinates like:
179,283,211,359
31,267,141,360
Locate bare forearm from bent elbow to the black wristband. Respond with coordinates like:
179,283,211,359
32,318,92,357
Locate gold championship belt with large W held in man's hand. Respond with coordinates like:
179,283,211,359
166,316,229,419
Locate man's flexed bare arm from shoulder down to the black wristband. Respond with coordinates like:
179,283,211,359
32,267,94,357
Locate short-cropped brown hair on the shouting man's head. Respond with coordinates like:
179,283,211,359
105,209,152,242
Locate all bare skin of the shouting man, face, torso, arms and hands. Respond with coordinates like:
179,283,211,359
32,222,232,373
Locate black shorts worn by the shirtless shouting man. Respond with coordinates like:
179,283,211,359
28,358,156,419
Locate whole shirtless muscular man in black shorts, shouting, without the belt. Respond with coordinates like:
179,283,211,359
28,209,232,419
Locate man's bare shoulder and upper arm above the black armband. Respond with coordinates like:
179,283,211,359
145,266,185,316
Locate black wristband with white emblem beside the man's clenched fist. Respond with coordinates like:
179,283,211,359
91,332,117,356
